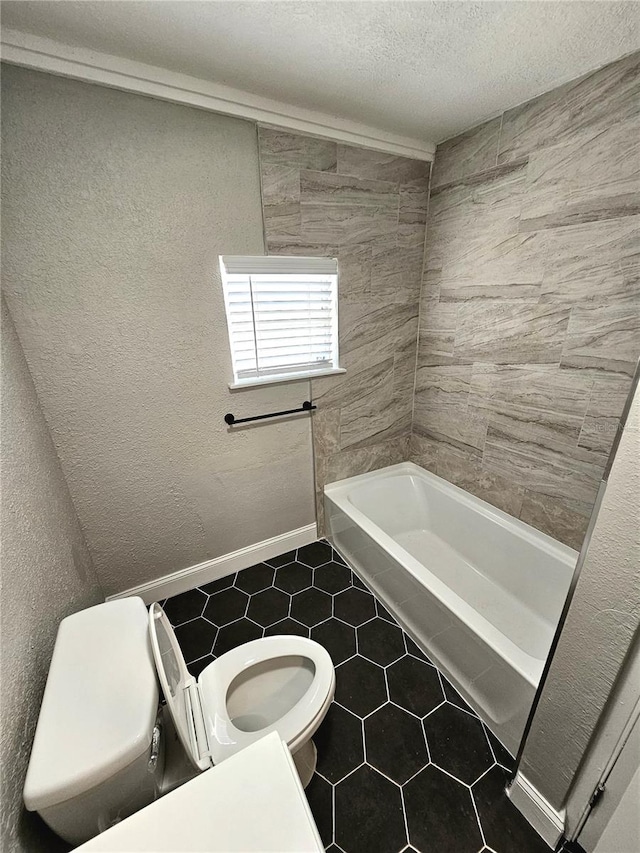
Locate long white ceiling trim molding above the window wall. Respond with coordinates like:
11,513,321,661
0,27,435,160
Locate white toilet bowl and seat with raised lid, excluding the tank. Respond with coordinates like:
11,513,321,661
149,603,335,770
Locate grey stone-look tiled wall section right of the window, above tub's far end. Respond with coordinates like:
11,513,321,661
259,128,430,529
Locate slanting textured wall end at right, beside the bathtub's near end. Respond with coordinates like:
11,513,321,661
520,380,640,808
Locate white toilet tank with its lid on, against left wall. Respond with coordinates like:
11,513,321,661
24,598,163,844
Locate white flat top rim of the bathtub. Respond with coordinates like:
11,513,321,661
324,462,578,689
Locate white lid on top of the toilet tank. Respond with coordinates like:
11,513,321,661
24,598,158,811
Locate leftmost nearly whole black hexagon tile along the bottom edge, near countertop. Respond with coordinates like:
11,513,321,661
335,765,407,853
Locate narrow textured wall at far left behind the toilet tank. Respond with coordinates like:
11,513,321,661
0,300,102,853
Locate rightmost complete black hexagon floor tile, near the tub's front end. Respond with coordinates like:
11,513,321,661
424,702,494,785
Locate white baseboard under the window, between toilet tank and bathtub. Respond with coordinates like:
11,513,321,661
107,522,318,604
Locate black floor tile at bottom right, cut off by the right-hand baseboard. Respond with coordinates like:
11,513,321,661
472,766,549,853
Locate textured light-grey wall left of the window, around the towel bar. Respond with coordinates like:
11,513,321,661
2,67,314,594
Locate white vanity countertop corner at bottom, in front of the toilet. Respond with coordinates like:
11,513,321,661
77,732,324,853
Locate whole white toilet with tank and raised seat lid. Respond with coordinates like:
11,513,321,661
24,598,335,844
